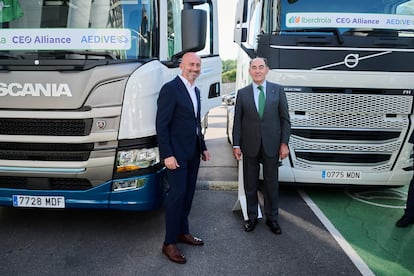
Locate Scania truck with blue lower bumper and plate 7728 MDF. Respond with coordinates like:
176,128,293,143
0,0,221,210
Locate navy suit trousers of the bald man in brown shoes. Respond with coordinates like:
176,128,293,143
164,154,200,245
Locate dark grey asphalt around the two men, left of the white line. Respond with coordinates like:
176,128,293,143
0,106,361,276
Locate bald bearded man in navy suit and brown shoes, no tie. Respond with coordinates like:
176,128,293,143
156,52,210,263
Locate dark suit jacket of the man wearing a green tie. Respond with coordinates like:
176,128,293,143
233,81,290,157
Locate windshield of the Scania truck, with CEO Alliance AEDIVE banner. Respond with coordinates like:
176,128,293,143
0,0,157,60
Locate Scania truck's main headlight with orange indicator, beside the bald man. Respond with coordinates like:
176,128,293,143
116,147,160,173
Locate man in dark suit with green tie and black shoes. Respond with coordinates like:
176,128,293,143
233,58,290,235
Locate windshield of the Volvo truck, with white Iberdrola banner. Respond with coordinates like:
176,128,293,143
277,0,414,37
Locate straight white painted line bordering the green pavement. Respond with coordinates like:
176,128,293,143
298,189,375,276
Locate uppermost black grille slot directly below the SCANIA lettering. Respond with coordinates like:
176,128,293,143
0,118,92,136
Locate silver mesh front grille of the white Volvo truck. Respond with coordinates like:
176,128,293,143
286,88,413,171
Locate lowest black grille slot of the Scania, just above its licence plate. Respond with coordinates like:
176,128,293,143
0,176,92,191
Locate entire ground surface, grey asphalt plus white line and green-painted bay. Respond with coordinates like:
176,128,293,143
0,106,414,275
